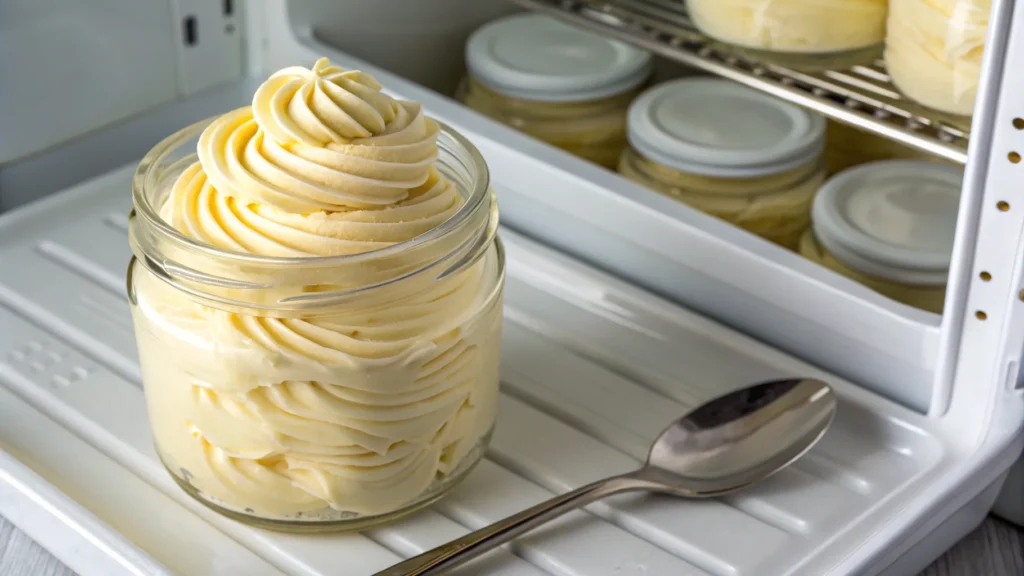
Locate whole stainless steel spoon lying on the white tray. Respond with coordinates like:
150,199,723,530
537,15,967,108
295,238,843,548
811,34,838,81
376,378,836,576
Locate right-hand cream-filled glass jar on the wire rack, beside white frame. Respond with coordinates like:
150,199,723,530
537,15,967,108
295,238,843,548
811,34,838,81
885,0,992,116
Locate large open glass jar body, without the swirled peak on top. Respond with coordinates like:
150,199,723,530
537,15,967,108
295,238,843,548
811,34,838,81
128,120,505,531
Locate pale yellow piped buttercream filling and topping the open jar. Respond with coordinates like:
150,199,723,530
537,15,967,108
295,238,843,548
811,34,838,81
134,59,501,519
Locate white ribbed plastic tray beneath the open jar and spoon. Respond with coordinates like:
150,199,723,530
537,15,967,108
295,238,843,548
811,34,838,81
0,153,1009,576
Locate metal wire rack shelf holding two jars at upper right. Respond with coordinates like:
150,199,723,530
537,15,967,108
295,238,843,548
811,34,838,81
513,0,971,164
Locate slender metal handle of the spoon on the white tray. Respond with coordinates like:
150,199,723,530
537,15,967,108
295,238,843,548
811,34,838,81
375,472,650,576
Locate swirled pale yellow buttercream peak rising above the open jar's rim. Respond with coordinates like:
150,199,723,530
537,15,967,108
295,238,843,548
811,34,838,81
163,58,461,256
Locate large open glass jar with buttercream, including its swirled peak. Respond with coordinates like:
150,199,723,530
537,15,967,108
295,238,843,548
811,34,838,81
128,58,504,532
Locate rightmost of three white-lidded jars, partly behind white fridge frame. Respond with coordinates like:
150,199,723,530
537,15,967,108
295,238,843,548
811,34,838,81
800,160,964,314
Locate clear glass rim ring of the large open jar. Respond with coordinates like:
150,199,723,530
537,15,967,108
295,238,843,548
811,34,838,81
132,115,490,268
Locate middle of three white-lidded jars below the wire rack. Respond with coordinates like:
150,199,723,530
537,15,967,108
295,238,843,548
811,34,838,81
618,78,825,249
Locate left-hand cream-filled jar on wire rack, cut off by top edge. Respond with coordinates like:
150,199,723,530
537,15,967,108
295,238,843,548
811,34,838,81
686,0,888,63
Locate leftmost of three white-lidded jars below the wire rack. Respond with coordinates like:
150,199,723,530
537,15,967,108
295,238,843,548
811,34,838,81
459,14,651,168
